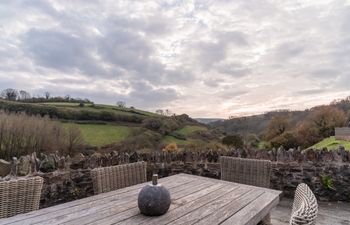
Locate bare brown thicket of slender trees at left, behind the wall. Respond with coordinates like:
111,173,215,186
0,111,83,160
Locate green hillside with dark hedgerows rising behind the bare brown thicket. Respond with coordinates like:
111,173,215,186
0,99,219,150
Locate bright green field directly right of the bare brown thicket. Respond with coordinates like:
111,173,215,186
63,123,133,147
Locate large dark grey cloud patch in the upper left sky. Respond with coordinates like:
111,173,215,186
23,29,106,75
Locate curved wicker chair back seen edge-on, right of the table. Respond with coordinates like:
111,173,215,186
289,184,318,225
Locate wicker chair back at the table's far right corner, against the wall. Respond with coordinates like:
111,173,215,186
220,156,271,188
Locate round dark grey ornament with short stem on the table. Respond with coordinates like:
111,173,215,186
138,174,171,216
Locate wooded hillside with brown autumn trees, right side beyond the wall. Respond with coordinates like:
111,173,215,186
218,97,350,149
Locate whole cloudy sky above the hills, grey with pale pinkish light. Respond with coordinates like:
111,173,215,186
0,0,350,117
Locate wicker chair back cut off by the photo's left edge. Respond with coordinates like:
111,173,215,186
0,177,44,218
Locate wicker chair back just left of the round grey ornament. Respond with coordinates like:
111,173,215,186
91,162,147,194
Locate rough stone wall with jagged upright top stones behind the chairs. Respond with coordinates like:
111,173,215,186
0,148,350,207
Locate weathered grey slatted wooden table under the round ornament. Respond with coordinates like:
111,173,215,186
0,174,281,225
